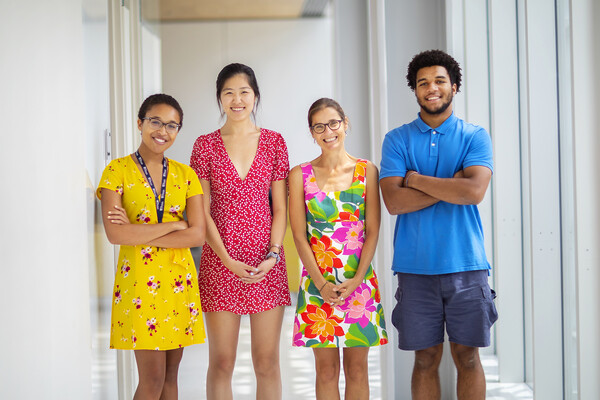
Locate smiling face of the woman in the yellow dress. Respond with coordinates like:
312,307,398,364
138,104,181,154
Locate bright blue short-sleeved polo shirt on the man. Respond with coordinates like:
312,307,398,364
380,113,493,275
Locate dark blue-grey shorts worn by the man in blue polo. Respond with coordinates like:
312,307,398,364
392,270,498,350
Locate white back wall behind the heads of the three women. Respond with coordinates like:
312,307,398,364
161,18,334,166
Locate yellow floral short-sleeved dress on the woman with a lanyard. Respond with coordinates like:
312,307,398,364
96,156,205,350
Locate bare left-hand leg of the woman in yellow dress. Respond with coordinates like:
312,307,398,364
133,350,167,400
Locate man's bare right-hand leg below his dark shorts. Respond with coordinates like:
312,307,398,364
450,343,485,400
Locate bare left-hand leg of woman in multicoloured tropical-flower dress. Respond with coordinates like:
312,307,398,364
313,348,340,400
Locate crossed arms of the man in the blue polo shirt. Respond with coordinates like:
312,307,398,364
379,165,492,215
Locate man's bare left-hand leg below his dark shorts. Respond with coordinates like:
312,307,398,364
412,343,443,400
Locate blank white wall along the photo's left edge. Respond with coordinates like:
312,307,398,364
0,0,90,399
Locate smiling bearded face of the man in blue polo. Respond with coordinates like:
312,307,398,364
415,65,456,116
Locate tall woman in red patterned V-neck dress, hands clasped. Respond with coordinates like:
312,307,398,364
190,64,290,400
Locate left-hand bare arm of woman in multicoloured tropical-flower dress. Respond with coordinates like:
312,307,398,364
289,166,339,304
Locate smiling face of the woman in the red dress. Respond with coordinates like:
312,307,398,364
219,74,256,121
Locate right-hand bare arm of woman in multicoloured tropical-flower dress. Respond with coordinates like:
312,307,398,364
339,161,381,298
